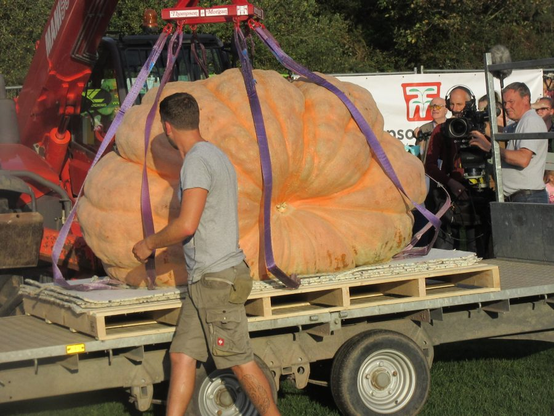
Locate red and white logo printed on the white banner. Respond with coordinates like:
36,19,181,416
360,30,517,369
402,82,441,121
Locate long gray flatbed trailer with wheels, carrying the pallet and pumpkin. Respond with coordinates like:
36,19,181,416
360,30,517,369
0,252,554,415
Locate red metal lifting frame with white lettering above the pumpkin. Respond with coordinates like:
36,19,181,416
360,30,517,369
162,0,264,26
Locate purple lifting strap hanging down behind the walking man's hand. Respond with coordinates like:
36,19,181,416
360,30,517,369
140,26,183,289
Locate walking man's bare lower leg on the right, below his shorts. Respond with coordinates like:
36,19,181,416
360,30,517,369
231,361,280,416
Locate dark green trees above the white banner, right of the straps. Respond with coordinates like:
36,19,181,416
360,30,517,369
318,0,554,70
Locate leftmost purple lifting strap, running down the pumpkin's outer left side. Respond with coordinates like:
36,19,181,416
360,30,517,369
52,30,169,292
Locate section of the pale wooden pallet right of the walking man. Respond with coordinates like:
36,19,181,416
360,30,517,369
246,264,500,322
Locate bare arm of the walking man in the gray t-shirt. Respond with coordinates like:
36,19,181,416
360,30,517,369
133,188,208,262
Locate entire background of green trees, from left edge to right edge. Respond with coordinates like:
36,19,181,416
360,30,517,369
0,0,554,85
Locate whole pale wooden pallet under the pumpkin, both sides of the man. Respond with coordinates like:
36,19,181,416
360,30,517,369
23,264,500,340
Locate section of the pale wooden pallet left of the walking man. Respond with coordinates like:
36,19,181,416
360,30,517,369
23,296,181,340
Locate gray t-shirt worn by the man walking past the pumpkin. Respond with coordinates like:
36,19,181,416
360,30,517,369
179,142,244,282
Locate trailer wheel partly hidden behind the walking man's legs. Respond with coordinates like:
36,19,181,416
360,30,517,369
186,355,277,416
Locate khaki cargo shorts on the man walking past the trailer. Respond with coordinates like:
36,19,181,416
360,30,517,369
169,262,254,369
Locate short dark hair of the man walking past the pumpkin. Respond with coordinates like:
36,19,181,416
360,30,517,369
160,92,200,130
